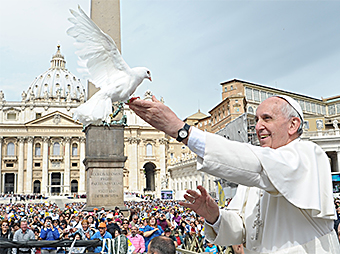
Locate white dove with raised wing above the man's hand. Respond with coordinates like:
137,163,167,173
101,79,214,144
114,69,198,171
67,6,151,127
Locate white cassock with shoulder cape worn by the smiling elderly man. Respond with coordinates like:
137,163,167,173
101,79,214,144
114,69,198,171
188,128,340,254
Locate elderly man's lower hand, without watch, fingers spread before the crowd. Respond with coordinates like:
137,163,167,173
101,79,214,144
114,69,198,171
179,185,220,224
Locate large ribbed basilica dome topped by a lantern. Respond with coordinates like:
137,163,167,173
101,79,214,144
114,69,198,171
22,45,85,102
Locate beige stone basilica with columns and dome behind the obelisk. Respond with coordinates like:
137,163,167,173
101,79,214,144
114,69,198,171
0,46,171,197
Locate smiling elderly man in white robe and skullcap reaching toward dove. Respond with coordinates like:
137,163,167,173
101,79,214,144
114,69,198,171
129,95,340,254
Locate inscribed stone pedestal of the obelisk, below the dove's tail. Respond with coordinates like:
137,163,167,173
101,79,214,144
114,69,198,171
84,125,127,211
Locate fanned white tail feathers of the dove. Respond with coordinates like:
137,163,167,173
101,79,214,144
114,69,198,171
73,93,112,126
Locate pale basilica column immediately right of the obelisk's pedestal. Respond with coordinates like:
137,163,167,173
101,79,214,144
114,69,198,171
128,138,140,192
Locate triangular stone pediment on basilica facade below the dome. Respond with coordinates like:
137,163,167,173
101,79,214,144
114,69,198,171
26,111,82,127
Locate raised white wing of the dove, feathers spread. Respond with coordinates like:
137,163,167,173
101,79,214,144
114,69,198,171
67,6,131,88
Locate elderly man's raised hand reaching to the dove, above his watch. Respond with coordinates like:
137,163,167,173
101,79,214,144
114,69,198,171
128,96,184,138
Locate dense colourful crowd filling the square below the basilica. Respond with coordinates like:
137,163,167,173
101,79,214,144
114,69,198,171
0,195,340,254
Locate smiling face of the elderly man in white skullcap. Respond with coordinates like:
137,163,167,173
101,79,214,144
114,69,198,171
256,97,290,149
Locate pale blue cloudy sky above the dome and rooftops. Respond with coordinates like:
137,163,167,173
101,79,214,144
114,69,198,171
0,0,340,119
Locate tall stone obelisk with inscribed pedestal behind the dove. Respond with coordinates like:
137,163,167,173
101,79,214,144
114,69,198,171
84,0,127,211
